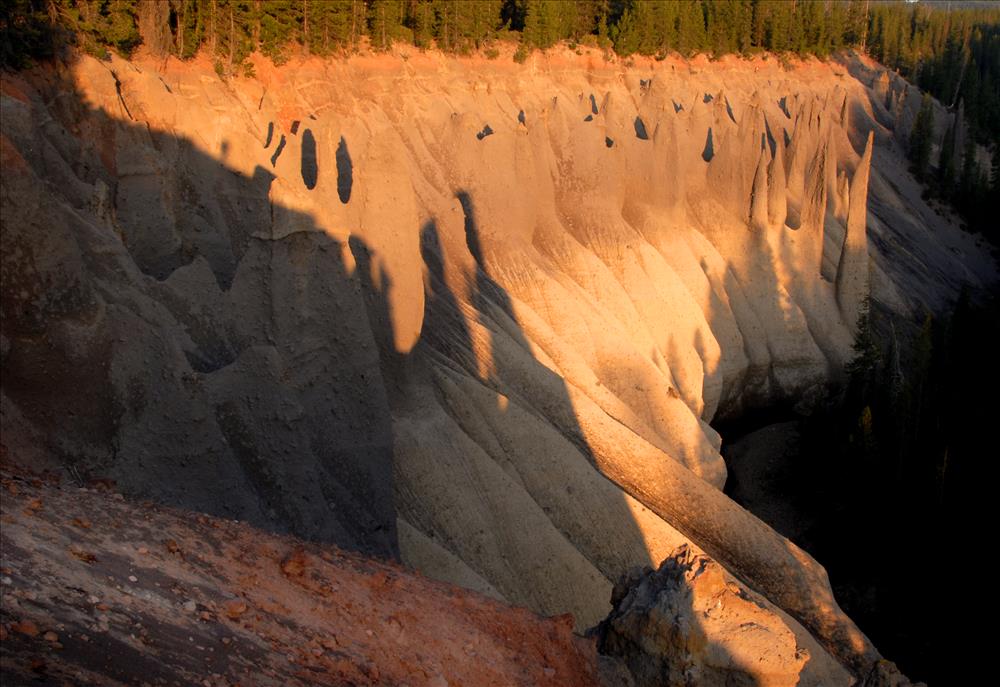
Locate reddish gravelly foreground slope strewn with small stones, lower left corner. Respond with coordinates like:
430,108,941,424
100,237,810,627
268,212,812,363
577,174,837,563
0,472,598,687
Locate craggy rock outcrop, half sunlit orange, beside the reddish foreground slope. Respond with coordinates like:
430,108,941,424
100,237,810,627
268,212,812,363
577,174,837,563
597,546,853,687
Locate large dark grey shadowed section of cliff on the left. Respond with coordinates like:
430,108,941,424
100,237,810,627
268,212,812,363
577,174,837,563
2,52,398,557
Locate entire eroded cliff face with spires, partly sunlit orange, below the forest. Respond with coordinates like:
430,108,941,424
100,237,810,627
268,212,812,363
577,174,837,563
2,48,992,675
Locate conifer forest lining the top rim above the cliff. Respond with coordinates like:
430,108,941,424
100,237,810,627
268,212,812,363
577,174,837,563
0,0,1000,238
